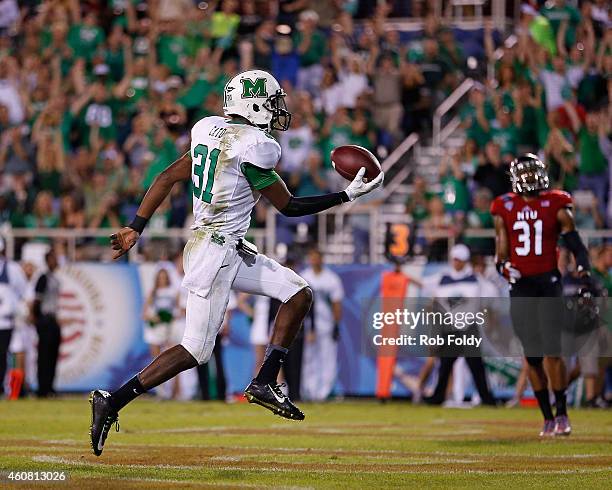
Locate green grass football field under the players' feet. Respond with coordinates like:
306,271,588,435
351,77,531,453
0,397,612,490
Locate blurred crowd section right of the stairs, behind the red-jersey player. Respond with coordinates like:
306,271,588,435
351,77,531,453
407,0,612,260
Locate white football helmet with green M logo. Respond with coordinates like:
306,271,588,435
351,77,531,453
223,70,291,131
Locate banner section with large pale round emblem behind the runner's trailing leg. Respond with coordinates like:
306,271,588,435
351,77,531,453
56,263,149,391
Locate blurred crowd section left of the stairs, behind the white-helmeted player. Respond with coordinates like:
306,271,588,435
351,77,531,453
0,0,482,260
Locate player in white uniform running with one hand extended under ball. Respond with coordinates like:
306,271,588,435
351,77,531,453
90,70,383,455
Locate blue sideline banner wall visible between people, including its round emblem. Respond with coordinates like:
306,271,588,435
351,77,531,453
28,263,520,396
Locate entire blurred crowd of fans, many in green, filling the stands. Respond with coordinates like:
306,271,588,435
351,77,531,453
0,0,612,260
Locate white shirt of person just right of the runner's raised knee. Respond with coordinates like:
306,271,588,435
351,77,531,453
301,267,344,333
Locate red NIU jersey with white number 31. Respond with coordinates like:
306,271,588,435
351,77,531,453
491,190,572,276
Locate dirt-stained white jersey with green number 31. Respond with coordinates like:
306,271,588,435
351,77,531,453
191,116,281,238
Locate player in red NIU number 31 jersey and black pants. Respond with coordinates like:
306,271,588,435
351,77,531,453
491,153,590,436
